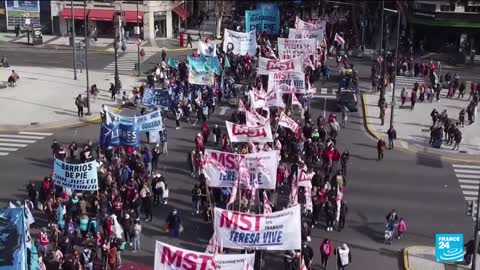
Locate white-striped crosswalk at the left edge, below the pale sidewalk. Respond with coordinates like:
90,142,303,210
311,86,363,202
0,131,53,156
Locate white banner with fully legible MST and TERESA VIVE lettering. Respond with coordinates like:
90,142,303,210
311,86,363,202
213,205,302,250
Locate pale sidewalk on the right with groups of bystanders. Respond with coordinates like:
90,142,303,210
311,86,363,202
362,85,480,160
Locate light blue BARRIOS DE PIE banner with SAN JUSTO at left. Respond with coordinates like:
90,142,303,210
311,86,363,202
53,159,98,191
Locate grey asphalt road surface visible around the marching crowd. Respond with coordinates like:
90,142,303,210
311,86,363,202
0,44,473,270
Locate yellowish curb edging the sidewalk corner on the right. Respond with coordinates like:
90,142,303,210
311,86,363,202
362,94,480,164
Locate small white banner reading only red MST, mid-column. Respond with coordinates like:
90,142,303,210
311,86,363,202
225,121,273,143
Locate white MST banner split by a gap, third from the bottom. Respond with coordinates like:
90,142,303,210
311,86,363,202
205,149,279,189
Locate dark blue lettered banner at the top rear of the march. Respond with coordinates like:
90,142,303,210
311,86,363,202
245,8,280,35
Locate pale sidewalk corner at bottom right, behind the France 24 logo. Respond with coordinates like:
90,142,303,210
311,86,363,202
403,246,480,270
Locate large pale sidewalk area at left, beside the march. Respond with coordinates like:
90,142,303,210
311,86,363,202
0,63,141,130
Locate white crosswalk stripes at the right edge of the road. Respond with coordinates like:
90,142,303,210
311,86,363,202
452,164,480,219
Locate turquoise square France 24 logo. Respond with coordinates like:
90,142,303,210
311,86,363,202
435,234,463,262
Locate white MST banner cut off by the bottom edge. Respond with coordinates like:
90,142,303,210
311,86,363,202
154,241,255,270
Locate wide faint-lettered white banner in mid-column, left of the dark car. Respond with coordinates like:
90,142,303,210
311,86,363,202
267,72,307,94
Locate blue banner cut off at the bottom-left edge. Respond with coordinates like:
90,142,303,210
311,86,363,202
0,208,27,270
